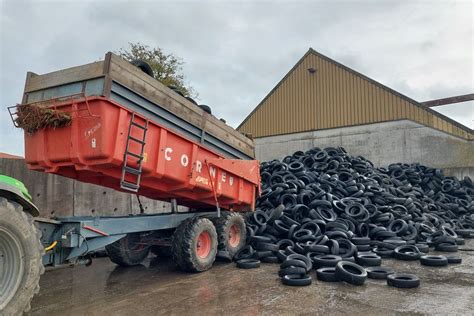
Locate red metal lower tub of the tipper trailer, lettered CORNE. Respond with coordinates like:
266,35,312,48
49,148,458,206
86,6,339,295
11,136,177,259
25,96,260,211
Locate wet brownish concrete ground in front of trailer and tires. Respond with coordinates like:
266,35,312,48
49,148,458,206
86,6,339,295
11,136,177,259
30,240,474,316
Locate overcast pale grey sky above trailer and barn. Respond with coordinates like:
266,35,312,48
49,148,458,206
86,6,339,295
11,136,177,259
0,0,474,155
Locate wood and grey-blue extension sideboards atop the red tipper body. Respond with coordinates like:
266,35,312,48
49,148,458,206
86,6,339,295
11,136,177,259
21,52,255,160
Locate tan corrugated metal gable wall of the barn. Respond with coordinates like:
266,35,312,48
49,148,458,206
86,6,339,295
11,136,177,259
238,49,474,139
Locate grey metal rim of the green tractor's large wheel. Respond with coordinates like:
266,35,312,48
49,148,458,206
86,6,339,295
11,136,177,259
0,227,25,310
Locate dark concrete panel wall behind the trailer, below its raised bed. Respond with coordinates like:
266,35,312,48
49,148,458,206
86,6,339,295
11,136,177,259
0,158,186,217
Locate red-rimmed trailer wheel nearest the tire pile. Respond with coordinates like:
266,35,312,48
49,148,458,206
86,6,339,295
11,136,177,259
211,212,247,258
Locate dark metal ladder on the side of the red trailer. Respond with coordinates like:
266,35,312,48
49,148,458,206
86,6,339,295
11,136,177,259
120,113,148,192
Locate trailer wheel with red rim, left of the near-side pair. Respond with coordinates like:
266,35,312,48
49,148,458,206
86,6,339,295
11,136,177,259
171,216,218,272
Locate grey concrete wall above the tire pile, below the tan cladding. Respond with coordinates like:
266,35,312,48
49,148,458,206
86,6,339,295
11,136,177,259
255,120,474,178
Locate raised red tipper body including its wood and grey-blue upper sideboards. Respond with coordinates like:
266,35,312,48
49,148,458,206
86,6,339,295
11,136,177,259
11,53,260,211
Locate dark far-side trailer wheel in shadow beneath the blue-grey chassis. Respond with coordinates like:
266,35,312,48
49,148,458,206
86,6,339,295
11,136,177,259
105,233,150,267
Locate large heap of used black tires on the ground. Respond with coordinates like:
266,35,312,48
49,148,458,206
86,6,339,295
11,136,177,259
234,147,474,287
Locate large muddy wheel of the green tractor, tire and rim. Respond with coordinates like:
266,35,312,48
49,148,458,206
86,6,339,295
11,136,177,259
0,197,44,315
